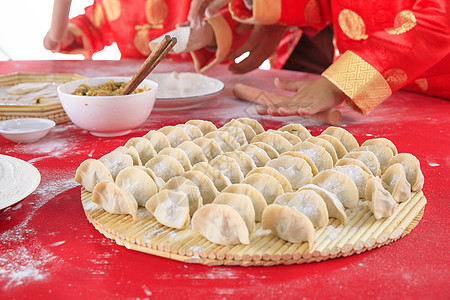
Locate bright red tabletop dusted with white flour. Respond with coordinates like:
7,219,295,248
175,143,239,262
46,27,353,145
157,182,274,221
0,60,450,299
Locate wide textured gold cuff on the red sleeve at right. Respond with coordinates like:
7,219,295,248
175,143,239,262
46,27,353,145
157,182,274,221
322,51,392,114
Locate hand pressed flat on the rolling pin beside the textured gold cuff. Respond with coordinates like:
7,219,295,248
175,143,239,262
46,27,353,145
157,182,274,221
258,78,346,116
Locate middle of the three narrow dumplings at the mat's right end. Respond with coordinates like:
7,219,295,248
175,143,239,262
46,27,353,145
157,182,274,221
381,163,411,202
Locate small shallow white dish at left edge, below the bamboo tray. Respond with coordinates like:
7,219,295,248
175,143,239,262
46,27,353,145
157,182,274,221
0,118,55,143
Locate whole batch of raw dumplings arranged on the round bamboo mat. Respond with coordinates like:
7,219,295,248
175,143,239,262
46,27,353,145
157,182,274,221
75,118,424,248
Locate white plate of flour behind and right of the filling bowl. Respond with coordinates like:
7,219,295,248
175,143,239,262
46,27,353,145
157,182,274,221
148,72,225,110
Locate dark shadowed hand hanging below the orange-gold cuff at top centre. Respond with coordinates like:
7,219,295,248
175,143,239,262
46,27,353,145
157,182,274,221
228,24,286,74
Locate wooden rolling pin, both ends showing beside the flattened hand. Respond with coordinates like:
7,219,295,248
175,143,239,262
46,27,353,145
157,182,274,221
233,83,341,125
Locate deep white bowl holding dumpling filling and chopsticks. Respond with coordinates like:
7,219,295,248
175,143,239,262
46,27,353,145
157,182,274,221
58,77,158,136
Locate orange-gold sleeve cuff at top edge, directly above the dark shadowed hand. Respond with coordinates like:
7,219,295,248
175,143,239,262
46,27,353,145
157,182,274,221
228,0,281,25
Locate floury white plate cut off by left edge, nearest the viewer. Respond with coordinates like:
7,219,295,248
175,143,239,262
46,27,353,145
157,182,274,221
0,154,41,209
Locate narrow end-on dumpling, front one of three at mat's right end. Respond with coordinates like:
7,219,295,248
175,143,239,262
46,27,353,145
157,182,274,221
366,177,397,220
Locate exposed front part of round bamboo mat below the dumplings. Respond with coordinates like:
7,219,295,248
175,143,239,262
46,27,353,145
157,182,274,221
81,188,427,266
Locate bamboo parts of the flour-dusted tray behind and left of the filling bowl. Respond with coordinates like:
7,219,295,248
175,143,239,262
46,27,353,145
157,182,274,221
0,73,85,123
